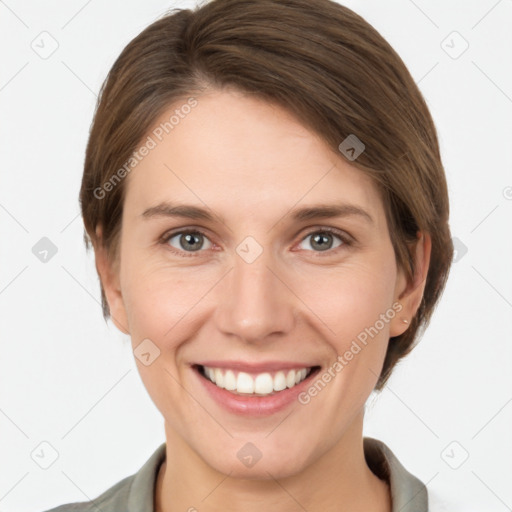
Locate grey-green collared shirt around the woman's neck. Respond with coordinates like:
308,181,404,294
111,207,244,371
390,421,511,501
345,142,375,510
46,437,428,512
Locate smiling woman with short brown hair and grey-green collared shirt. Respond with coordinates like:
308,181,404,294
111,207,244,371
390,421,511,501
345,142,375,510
44,0,453,512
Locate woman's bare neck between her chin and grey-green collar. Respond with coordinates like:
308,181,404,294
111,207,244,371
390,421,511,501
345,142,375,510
155,413,391,512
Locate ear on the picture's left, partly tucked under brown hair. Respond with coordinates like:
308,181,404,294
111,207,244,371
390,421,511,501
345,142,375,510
93,226,130,334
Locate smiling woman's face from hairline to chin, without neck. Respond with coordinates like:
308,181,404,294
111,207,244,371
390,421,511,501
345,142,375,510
100,91,412,478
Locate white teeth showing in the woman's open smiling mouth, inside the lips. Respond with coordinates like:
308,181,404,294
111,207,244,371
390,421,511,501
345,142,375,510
193,364,320,396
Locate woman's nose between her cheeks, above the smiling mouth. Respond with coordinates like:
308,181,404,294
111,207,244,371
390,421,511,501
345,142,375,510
215,247,298,343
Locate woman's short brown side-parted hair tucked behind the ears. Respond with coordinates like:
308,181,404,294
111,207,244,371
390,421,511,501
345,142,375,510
80,0,453,389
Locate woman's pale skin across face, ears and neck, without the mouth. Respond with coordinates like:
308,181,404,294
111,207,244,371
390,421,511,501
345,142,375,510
95,86,430,512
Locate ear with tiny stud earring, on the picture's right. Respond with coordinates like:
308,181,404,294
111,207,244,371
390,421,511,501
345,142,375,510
390,231,432,337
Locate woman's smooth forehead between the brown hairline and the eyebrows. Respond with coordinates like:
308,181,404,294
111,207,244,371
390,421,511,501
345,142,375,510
125,91,383,228
